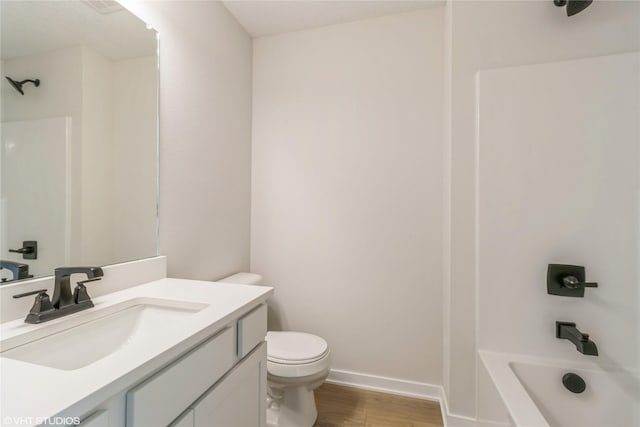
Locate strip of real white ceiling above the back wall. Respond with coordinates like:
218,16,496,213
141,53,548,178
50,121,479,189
222,0,445,37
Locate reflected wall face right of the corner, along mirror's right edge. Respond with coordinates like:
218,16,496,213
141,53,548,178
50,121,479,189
111,56,158,260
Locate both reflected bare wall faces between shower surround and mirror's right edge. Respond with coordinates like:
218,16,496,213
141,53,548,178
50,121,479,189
82,48,158,265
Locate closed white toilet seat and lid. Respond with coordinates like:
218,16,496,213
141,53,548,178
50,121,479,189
266,332,329,378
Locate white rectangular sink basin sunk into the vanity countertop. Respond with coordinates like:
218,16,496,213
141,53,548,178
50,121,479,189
1,299,207,370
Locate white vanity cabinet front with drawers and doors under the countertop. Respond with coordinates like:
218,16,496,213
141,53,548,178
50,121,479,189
80,304,267,427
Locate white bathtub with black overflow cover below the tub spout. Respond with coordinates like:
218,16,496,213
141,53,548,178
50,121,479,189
479,351,640,427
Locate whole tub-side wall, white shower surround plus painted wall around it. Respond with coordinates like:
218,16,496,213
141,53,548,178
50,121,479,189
444,1,640,420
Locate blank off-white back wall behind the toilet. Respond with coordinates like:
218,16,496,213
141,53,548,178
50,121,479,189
251,9,443,384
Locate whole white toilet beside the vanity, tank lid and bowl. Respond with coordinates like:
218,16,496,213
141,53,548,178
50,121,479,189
218,273,330,427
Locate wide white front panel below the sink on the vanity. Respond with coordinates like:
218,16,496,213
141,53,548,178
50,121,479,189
127,328,236,427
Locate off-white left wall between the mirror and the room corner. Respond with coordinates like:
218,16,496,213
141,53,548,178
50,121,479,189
121,0,252,280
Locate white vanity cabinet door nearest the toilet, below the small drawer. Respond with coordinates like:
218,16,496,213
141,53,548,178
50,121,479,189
194,342,267,427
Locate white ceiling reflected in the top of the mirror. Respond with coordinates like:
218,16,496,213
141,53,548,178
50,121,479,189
0,0,156,60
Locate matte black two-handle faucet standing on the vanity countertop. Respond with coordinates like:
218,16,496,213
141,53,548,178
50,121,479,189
13,267,103,323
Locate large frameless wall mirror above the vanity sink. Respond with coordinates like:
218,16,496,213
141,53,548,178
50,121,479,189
0,0,160,286
